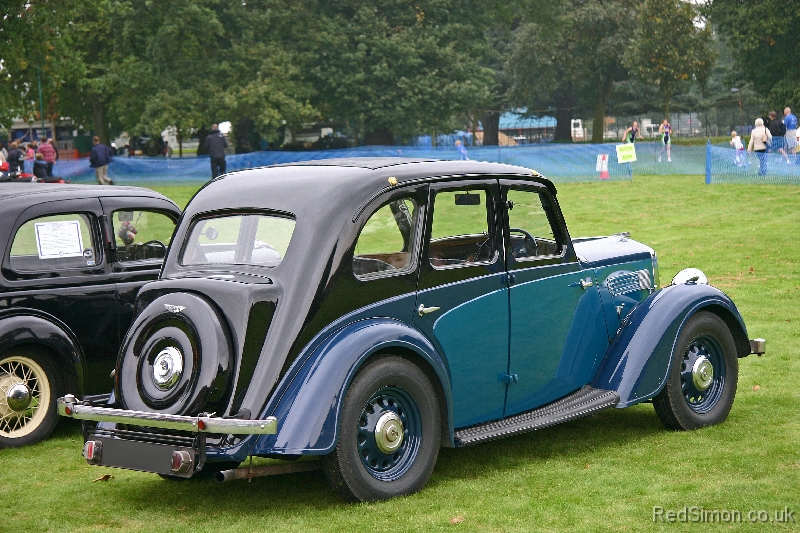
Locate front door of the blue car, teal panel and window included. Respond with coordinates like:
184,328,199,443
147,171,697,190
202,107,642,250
501,182,608,416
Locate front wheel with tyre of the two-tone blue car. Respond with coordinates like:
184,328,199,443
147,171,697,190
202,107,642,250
653,311,739,430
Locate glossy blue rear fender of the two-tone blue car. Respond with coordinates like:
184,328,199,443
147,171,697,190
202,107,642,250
251,318,453,455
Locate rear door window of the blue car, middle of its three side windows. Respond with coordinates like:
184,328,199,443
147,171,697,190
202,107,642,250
428,189,495,268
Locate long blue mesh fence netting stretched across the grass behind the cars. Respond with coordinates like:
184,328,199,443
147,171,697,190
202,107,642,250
54,142,800,184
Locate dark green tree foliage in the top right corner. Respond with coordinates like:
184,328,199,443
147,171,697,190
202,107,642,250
706,0,800,108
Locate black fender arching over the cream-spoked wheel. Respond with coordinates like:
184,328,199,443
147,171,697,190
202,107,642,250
0,308,84,397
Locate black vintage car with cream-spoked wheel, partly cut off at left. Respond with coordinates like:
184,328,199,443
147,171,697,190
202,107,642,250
0,184,180,446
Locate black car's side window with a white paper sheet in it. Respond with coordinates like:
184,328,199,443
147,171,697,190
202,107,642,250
9,213,98,272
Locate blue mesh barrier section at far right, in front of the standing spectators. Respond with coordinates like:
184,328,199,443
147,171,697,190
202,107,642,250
704,145,800,184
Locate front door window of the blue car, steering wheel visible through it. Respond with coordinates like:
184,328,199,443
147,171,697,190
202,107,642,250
508,190,562,260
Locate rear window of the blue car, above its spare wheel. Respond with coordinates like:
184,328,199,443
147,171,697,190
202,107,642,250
181,214,295,267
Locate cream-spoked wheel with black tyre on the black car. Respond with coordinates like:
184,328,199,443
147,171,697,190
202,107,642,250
0,349,63,447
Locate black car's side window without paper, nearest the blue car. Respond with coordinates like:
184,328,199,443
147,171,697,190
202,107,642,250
111,210,175,262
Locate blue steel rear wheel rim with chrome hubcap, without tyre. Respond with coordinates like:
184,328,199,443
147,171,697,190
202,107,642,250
356,387,422,481
